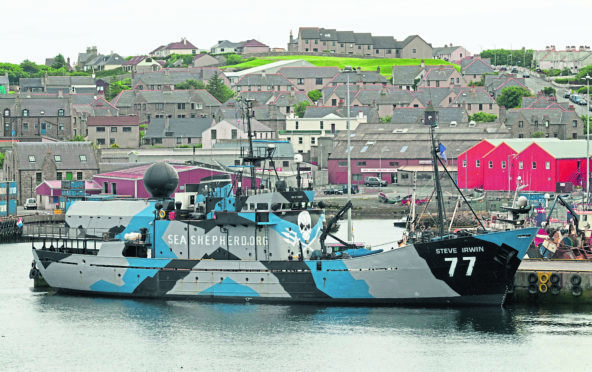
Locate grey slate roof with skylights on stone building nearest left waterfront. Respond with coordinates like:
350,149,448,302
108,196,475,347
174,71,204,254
14,142,98,170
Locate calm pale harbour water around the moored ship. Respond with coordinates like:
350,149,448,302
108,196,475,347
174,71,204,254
0,220,592,371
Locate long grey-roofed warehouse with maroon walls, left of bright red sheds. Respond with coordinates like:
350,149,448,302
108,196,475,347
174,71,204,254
327,123,504,186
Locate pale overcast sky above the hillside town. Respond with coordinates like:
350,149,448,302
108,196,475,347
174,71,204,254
0,0,592,64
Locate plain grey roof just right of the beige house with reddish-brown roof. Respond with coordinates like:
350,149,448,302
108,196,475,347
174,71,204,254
144,117,214,138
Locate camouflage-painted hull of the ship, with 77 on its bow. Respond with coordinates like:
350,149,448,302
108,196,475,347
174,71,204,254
33,229,536,306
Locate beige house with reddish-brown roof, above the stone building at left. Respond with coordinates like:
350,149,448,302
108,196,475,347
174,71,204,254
86,116,140,148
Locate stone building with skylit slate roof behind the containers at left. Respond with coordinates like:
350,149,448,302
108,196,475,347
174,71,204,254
4,142,99,203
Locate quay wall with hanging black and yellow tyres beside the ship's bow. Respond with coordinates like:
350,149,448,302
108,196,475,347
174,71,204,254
508,259,592,305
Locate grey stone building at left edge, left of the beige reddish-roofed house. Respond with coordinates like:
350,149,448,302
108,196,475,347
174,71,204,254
0,94,78,141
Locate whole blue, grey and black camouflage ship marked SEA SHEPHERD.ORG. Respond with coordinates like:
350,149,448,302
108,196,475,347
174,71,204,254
32,101,537,306
